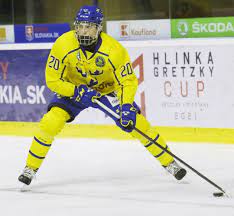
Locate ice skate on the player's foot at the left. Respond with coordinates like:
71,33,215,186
18,166,37,191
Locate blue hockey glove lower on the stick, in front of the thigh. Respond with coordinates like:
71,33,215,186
117,104,137,132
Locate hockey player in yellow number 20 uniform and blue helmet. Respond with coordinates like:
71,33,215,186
18,6,186,185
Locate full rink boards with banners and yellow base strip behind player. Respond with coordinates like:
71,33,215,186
0,39,234,143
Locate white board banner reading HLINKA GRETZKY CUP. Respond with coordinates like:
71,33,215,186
125,40,234,128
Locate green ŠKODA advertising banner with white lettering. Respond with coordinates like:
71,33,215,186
171,17,234,38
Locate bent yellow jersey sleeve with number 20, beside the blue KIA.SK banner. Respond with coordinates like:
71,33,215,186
45,38,75,97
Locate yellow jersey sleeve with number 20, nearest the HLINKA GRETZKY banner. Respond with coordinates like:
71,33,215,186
109,46,138,104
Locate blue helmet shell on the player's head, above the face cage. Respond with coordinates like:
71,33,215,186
75,5,103,25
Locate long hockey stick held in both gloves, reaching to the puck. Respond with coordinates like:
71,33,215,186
94,99,230,197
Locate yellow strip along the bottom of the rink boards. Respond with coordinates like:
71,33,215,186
0,122,234,144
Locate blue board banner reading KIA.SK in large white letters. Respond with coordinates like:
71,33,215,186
0,50,52,122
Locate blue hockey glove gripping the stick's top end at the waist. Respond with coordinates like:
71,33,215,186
73,85,101,108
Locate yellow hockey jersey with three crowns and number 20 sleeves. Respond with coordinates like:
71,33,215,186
45,30,138,104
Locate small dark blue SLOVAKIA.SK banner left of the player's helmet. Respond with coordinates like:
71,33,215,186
14,23,70,43
